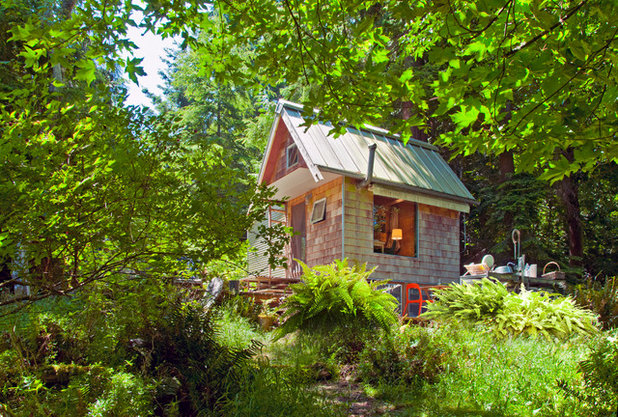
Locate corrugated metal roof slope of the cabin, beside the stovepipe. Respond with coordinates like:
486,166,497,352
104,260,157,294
281,102,474,201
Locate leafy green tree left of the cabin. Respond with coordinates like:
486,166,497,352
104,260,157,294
0,0,284,304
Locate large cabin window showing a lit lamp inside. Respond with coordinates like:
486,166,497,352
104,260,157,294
373,195,418,256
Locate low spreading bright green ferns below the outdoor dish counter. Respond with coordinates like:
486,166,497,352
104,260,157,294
425,278,597,338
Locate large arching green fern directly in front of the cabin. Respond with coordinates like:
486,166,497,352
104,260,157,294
277,259,398,352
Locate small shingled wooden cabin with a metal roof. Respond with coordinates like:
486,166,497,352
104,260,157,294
249,101,474,305
